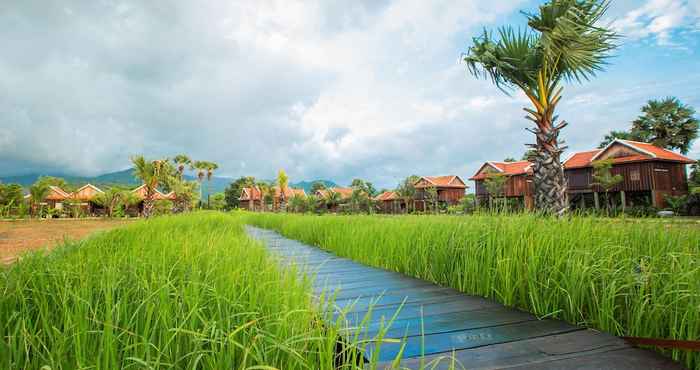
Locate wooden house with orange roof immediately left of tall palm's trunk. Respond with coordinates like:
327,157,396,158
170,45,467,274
470,161,534,209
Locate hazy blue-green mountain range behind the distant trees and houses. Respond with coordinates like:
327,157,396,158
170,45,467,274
0,168,338,196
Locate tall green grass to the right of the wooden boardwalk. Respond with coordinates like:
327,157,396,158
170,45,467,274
247,214,700,368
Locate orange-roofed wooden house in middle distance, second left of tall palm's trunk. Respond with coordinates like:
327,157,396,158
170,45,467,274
413,175,468,211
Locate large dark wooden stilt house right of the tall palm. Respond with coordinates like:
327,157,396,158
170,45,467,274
564,139,695,208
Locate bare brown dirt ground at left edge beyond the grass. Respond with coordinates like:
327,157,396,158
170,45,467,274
0,219,133,264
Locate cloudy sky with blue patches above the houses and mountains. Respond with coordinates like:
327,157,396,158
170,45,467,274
0,0,700,188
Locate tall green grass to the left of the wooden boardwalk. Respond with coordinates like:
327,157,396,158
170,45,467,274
0,213,372,369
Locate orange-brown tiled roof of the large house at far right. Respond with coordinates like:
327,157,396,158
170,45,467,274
564,139,695,169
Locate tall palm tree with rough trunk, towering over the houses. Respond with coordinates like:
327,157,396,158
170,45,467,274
464,0,618,214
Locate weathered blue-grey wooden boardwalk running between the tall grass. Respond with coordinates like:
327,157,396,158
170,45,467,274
247,227,682,370
